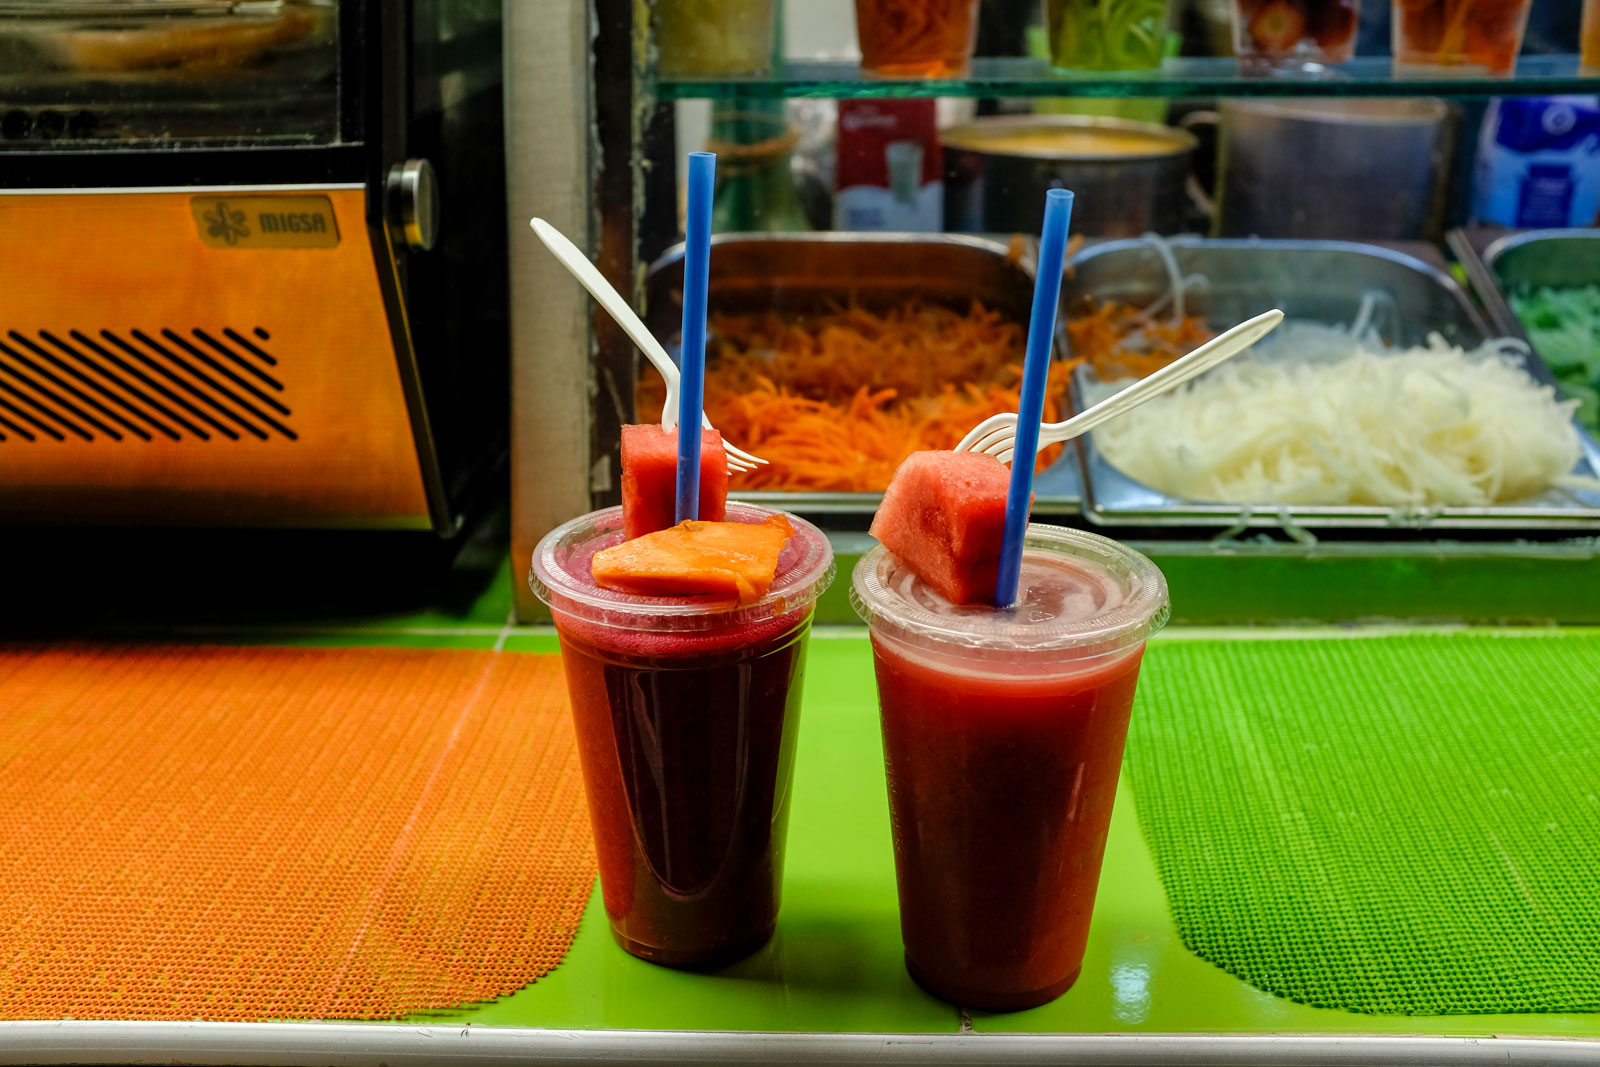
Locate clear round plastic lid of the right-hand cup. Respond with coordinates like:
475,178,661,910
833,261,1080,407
850,523,1171,657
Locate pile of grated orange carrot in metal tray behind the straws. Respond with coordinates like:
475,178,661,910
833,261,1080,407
637,301,1208,493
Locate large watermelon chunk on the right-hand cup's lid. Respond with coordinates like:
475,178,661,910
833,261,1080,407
870,451,1011,605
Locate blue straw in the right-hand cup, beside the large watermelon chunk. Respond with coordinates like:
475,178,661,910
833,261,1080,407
995,189,1072,608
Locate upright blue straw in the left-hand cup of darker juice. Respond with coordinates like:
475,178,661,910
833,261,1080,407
675,152,717,523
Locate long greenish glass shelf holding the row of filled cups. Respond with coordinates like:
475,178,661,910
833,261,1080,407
654,56,1600,101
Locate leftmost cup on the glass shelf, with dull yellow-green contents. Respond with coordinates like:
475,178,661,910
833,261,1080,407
654,0,774,77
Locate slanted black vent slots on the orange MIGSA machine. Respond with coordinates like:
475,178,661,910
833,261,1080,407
0,326,298,443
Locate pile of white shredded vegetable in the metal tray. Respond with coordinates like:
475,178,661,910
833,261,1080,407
1091,329,1600,507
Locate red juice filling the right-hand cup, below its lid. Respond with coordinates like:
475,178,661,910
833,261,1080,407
872,640,1142,1011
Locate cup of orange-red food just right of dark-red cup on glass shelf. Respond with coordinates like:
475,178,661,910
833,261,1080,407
1394,0,1533,77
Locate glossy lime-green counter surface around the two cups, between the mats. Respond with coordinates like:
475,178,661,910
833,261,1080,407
448,627,1600,1038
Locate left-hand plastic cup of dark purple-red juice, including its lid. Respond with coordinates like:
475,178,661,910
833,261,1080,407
528,502,834,966
